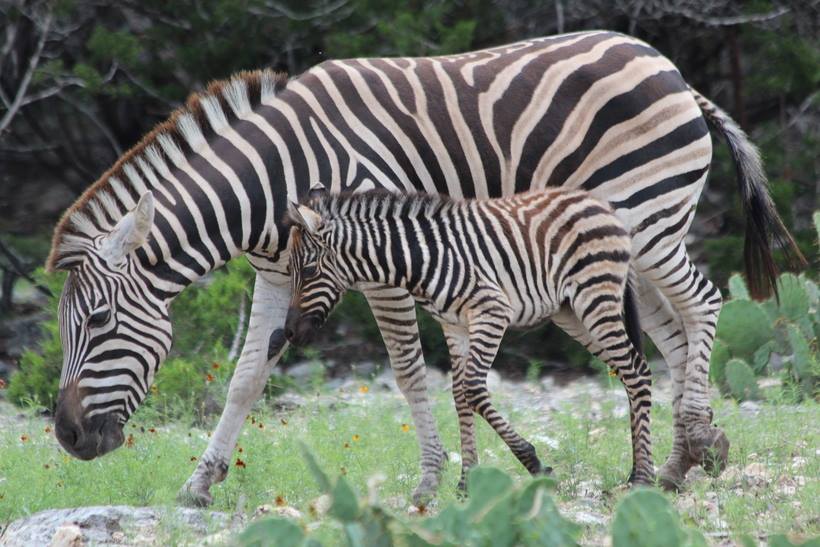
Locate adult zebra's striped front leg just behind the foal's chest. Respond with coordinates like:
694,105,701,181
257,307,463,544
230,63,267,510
362,287,445,505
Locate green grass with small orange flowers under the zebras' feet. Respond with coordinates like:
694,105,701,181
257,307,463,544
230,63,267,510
0,384,820,544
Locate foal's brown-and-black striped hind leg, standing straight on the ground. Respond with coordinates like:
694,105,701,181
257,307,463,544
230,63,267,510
572,300,655,484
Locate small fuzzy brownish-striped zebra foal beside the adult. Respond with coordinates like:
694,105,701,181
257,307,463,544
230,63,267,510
285,189,655,487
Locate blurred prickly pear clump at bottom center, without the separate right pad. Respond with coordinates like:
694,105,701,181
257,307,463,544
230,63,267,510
239,446,580,547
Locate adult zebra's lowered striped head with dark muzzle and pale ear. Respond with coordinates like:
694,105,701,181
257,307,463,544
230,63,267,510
55,192,171,460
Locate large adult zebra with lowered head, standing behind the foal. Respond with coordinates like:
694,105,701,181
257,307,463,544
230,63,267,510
47,27,793,503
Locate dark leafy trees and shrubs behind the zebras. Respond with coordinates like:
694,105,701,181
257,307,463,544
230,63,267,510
0,0,820,417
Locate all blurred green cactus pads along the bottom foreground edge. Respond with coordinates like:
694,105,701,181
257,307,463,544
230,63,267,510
238,445,752,547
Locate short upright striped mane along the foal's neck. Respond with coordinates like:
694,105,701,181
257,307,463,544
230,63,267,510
309,189,459,221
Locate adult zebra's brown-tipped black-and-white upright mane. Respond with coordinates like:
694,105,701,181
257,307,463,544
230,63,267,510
46,69,288,272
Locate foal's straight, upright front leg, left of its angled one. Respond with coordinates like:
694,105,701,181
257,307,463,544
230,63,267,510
442,324,478,491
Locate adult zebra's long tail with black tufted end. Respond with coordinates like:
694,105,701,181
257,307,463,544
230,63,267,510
689,87,807,299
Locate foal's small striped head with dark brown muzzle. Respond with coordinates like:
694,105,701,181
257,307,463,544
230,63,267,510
285,205,350,346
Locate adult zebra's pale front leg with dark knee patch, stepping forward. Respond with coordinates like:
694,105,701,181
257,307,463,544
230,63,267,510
177,273,290,507
